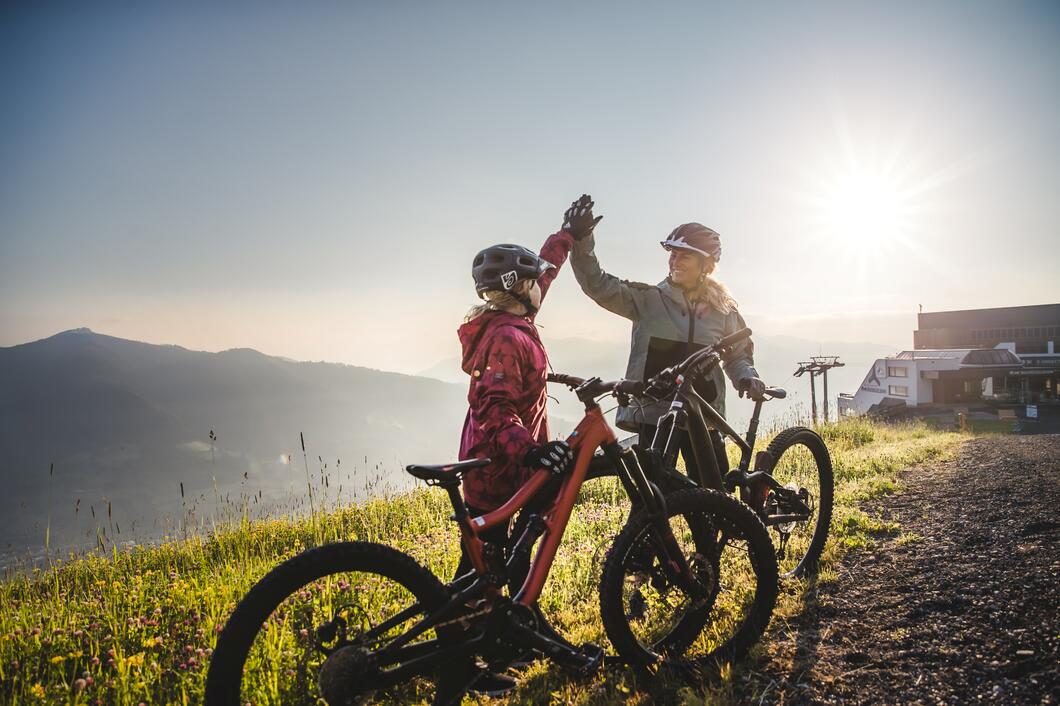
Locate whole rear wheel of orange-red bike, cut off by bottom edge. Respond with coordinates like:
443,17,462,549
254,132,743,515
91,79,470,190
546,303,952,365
206,542,462,706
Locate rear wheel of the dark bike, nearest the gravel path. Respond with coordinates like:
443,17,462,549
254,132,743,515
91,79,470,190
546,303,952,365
764,426,834,578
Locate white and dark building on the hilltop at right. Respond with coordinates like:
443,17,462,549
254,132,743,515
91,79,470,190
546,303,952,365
838,304,1060,414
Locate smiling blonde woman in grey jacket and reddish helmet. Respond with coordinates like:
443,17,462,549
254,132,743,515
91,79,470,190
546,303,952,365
570,209,765,486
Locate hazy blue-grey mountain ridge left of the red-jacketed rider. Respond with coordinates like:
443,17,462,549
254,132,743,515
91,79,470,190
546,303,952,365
0,329,466,551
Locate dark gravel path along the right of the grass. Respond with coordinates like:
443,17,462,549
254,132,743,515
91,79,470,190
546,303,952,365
743,435,1060,705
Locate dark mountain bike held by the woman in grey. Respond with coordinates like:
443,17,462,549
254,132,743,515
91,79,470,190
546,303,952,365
589,329,834,578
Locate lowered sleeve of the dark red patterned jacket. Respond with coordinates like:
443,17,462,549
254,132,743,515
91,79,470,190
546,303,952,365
469,331,536,463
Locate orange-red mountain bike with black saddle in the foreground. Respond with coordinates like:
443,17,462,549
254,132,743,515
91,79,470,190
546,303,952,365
206,330,777,706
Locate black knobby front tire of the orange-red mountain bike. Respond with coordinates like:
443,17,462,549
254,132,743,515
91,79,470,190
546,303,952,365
600,489,778,667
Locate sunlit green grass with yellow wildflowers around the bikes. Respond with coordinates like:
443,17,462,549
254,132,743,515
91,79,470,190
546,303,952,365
0,420,967,704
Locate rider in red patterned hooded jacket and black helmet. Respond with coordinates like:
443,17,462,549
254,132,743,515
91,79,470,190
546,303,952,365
457,195,598,695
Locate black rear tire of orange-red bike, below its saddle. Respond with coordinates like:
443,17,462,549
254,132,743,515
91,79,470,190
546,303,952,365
205,542,460,706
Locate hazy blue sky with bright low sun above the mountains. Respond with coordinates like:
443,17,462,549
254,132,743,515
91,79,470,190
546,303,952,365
0,0,1060,372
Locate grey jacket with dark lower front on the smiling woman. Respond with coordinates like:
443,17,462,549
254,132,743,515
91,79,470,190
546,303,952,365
570,235,758,431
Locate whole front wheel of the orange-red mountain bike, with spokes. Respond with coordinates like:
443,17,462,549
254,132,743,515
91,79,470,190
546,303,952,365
600,489,777,666
